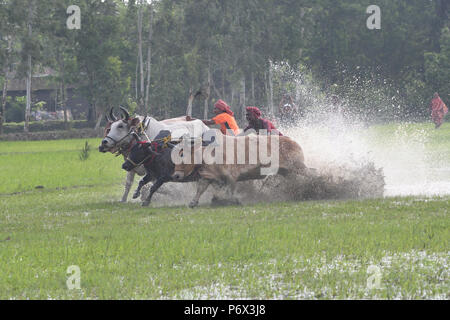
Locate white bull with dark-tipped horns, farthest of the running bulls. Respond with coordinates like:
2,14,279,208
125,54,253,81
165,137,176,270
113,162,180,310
99,107,209,202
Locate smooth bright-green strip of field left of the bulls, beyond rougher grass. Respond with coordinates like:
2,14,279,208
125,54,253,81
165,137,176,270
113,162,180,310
0,139,125,194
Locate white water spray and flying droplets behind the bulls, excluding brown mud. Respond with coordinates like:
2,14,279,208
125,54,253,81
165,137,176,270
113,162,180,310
266,63,450,197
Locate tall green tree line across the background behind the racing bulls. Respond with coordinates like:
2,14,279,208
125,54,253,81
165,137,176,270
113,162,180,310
0,0,450,131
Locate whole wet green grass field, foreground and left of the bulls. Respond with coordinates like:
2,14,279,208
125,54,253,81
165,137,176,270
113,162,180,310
0,127,450,299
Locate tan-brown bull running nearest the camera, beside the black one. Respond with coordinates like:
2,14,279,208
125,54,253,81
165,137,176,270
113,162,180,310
172,135,312,207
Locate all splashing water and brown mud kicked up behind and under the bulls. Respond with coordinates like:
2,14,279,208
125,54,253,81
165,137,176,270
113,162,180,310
139,63,450,205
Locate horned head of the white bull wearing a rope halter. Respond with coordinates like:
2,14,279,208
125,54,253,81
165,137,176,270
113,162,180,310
98,107,139,152
